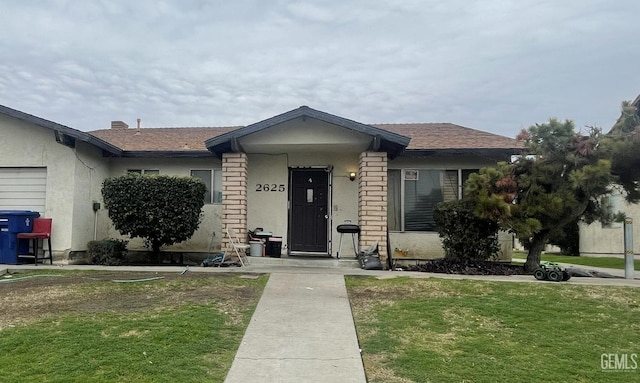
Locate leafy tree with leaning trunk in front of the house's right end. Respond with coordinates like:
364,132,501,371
466,119,616,270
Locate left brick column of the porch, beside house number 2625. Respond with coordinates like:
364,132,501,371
222,153,248,251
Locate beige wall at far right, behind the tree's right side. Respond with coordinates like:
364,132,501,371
580,202,640,256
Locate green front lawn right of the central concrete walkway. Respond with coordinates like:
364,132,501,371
347,277,640,383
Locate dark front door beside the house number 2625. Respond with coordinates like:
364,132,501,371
289,169,329,253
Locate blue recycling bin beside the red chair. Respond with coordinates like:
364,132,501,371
0,210,40,265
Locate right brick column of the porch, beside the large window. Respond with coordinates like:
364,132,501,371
358,152,387,268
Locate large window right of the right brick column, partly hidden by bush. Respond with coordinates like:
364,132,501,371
387,168,477,231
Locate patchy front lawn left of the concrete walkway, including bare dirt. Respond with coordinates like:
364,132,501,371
0,272,267,383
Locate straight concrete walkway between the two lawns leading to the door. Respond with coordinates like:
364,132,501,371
225,273,366,383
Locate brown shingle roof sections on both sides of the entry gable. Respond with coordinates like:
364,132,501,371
89,123,522,151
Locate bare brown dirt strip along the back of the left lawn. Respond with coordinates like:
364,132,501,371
0,272,261,336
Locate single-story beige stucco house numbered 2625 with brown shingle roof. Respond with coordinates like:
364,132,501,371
0,106,522,268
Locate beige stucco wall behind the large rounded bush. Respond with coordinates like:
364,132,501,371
104,157,222,252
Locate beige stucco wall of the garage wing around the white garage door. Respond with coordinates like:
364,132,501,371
0,115,107,258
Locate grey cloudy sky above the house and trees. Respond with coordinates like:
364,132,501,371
0,0,640,137
